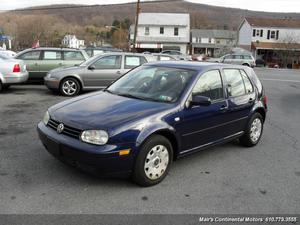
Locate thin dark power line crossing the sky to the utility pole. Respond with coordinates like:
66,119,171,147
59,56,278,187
7,0,183,12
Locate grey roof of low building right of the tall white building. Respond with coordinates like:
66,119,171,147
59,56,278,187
191,29,237,39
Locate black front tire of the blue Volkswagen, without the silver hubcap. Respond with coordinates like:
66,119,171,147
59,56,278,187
132,135,173,187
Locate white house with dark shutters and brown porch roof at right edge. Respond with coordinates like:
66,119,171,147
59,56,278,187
238,18,300,65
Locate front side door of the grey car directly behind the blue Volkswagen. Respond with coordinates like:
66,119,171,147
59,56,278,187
81,55,124,87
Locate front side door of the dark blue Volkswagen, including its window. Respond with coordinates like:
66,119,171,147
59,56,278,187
177,70,228,153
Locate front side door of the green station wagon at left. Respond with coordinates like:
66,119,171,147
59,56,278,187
17,50,43,80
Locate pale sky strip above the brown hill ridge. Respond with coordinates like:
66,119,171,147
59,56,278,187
0,0,300,13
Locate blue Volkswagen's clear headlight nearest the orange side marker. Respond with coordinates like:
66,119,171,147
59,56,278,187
80,130,108,145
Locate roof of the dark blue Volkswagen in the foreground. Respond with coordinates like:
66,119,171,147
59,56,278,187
144,61,252,72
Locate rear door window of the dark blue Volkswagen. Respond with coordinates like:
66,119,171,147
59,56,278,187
224,69,246,97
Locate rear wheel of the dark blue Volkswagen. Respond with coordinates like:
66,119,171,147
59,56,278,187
240,113,264,147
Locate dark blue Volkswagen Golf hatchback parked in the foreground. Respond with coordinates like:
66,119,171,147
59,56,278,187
38,62,267,186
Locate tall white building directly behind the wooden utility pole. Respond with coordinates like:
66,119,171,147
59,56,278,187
130,13,190,54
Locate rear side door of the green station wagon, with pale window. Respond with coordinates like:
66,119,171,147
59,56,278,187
40,50,63,76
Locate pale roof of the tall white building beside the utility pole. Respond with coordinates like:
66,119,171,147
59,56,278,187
139,13,190,26
